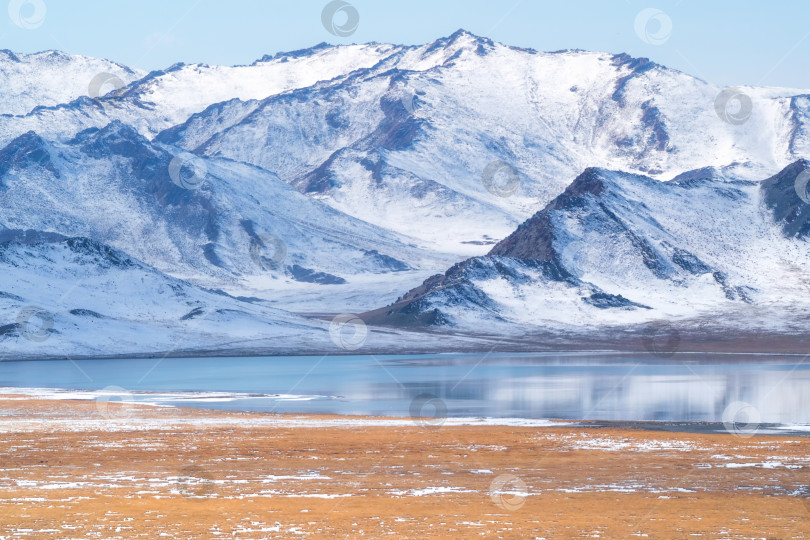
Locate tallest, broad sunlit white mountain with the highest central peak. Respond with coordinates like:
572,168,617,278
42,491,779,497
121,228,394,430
158,31,810,255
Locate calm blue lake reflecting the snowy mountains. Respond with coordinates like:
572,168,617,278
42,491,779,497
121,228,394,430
0,353,810,424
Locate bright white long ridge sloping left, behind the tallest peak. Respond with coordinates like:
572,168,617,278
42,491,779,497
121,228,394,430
0,44,410,149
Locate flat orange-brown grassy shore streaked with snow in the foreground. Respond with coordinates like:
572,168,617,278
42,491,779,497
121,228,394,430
0,395,810,539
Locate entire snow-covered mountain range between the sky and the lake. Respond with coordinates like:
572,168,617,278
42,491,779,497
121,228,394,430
0,31,810,357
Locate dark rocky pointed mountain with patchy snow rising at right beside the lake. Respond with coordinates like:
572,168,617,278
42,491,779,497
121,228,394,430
367,160,810,332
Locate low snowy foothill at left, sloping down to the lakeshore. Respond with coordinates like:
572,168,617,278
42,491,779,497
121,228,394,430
0,229,329,359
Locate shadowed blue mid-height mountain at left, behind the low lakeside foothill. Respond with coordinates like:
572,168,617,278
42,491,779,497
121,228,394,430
0,123,448,311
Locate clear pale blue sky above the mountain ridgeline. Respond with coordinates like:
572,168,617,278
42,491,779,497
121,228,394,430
0,0,810,88
